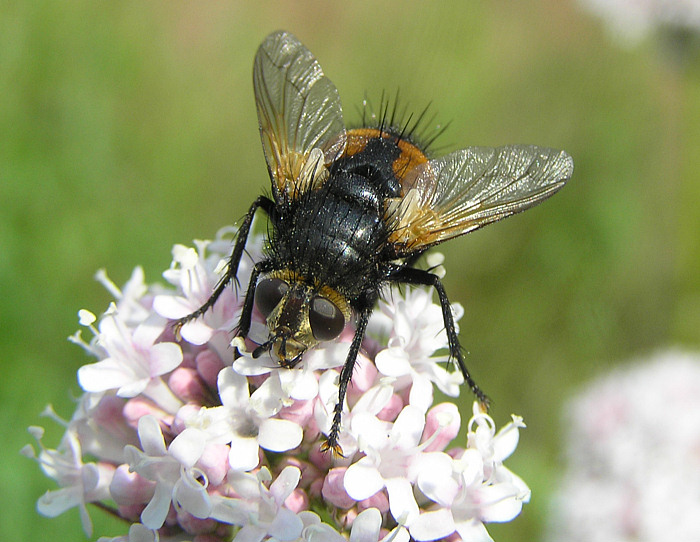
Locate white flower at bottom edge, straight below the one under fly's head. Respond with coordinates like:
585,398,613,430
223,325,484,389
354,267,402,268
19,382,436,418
211,467,304,542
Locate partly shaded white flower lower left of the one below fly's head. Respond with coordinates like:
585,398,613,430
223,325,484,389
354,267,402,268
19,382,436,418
124,415,211,529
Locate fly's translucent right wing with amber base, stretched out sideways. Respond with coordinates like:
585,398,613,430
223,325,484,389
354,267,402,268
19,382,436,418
385,145,574,254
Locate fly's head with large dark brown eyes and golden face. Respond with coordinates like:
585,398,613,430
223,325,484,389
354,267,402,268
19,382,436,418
255,270,351,368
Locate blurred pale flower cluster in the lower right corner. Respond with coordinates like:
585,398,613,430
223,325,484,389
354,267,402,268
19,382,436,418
548,351,700,542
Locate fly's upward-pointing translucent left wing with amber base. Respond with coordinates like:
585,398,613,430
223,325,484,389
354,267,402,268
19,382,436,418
253,32,345,199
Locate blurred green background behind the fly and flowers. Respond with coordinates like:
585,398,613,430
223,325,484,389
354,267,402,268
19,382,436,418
0,0,700,541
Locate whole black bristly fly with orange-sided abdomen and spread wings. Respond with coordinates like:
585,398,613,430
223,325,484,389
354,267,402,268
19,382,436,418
176,32,573,454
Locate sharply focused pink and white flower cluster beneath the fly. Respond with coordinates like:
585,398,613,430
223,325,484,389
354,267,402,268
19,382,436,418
23,228,530,542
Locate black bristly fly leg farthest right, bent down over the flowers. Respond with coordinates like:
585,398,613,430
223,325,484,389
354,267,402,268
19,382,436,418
388,267,490,408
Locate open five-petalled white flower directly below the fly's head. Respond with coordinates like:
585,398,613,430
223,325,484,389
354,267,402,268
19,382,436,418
188,367,303,471
